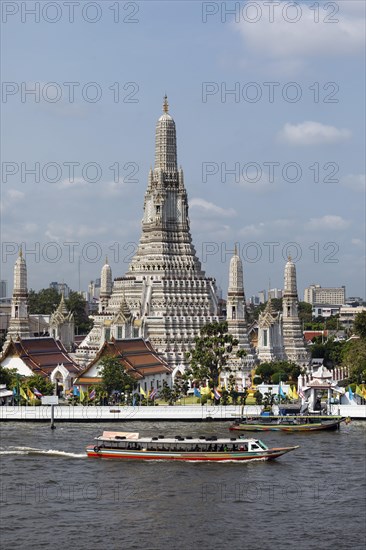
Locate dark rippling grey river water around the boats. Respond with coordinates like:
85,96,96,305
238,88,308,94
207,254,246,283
0,421,366,550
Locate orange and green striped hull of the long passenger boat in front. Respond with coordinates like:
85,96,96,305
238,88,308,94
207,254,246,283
86,445,298,462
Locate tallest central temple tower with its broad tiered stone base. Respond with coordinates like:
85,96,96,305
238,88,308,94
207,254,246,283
77,97,219,369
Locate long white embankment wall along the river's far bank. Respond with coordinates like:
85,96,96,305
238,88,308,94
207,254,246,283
0,405,366,422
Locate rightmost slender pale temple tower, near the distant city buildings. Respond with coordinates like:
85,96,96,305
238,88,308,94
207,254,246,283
282,257,309,366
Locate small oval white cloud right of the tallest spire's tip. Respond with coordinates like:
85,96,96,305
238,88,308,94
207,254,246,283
277,120,351,146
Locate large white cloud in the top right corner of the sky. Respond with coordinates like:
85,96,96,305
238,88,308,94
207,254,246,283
232,1,365,63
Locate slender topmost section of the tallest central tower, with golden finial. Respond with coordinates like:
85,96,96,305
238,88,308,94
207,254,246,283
155,96,177,173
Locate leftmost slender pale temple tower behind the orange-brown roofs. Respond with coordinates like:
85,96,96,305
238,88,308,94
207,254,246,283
4,248,31,348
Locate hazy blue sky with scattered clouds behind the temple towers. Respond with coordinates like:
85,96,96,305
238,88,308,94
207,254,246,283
1,0,366,298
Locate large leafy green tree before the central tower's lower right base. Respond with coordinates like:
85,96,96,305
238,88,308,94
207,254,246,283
186,321,238,389
